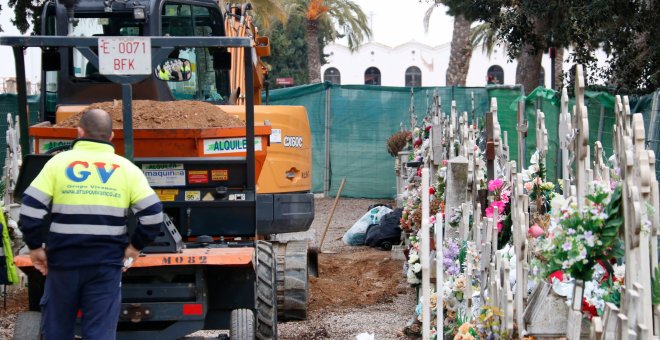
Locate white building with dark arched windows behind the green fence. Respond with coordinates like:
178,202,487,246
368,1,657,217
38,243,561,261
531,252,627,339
321,40,550,87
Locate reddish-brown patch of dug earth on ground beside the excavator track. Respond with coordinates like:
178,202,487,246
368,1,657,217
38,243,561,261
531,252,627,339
309,249,405,311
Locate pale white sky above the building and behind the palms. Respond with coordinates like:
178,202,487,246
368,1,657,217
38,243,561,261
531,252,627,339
0,0,453,81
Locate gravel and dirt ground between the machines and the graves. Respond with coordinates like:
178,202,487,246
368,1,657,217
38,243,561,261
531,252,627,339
0,198,415,340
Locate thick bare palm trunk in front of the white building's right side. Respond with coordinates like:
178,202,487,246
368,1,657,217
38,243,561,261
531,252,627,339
446,15,472,86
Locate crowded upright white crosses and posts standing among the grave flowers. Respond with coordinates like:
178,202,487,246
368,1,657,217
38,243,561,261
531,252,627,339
400,66,660,339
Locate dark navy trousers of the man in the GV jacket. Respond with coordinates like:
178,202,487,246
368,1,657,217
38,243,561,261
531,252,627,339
41,265,121,340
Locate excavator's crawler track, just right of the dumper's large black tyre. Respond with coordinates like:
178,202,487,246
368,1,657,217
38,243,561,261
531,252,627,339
277,241,309,321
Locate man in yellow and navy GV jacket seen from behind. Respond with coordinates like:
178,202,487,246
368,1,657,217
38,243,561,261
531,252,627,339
20,109,163,340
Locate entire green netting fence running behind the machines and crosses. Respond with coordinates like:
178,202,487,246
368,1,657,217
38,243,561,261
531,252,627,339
0,83,660,199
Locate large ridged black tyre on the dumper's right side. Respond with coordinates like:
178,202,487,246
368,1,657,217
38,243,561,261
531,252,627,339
254,241,277,340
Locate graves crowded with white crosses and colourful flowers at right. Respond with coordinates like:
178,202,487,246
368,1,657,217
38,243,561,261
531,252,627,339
396,66,660,339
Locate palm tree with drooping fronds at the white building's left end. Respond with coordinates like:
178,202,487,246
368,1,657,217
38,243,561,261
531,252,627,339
293,0,371,83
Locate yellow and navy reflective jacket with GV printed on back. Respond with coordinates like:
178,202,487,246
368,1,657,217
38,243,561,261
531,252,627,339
19,139,163,268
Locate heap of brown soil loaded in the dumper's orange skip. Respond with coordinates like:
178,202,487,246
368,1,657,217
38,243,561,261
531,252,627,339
57,100,245,129
